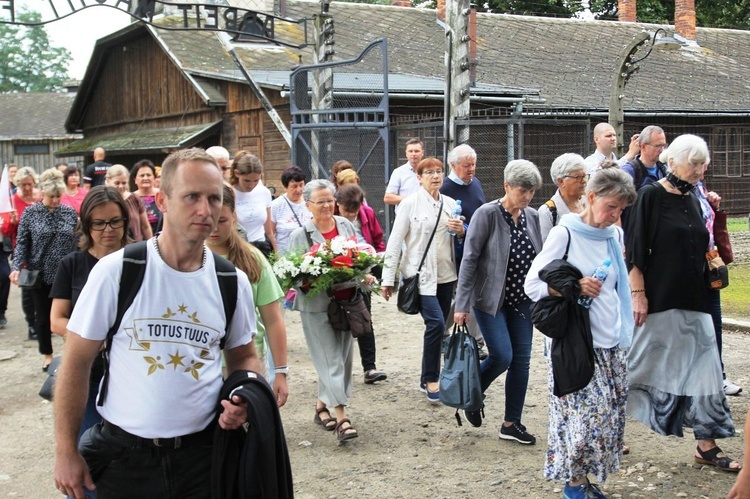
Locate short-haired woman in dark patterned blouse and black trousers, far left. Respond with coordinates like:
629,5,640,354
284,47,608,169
10,168,78,372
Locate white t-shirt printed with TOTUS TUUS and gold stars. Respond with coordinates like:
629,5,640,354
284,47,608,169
68,242,256,438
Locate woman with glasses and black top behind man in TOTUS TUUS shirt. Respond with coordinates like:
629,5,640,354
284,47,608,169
49,188,128,496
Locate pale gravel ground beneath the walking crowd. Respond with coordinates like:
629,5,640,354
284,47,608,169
0,289,750,499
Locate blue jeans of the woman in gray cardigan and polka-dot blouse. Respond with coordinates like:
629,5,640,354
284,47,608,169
474,300,533,423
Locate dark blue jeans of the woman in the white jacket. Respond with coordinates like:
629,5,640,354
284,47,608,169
419,281,456,384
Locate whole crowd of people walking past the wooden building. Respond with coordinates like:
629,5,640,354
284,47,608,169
0,123,750,499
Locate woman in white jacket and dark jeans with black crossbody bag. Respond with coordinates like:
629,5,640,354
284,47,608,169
382,158,464,404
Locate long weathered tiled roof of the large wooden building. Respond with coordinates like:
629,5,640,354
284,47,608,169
76,0,750,121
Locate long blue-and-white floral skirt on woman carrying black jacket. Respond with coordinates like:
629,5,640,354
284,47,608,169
544,347,628,482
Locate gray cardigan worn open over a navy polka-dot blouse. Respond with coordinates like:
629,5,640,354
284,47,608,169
456,201,542,316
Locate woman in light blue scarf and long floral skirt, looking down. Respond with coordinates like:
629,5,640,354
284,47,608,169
524,168,636,499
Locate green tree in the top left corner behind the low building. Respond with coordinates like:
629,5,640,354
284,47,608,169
0,11,70,92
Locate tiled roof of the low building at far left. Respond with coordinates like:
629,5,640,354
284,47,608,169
0,93,80,140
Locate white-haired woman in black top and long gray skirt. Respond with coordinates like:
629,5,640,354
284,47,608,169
626,135,741,472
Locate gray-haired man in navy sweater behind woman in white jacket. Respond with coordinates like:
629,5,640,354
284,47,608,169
440,144,494,359
